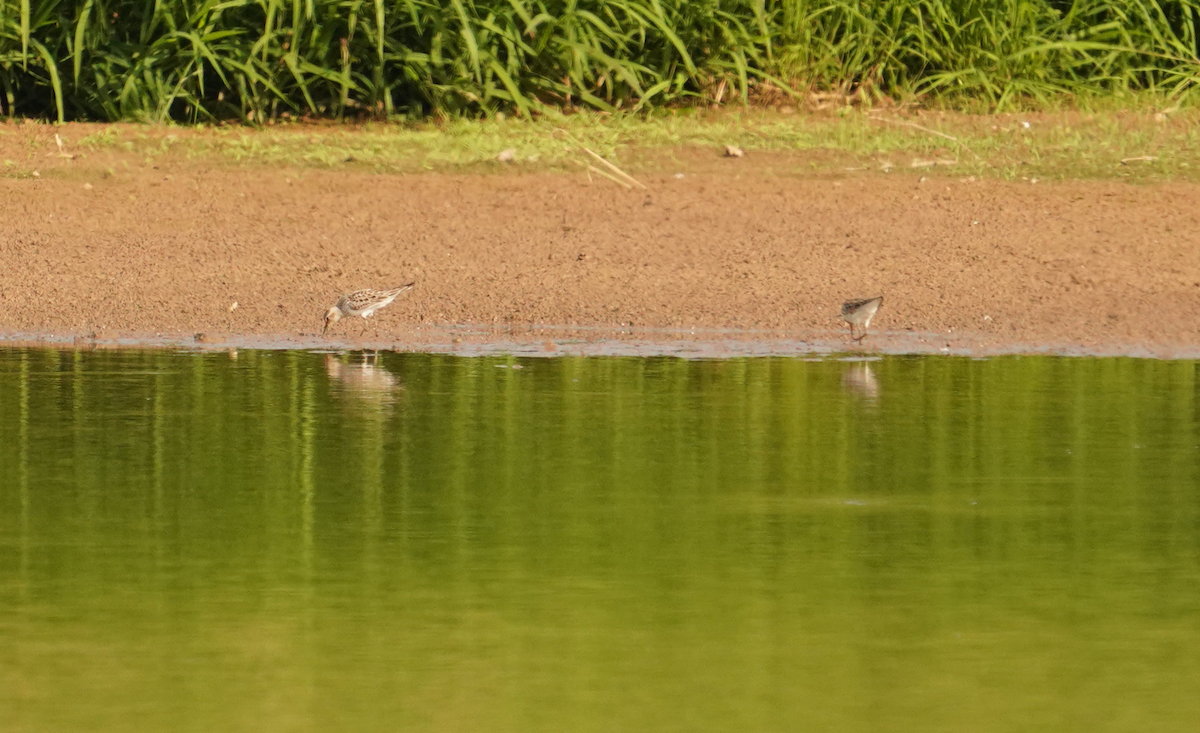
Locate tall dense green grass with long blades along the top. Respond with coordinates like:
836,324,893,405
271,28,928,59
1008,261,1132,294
7,0,1200,122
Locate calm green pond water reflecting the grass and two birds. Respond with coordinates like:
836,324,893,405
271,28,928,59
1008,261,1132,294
0,350,1200,733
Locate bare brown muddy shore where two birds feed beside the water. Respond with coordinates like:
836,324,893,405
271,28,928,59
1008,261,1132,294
0,128,1200,356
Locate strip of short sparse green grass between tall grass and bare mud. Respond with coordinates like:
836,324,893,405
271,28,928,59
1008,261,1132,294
9,107,1200,181
